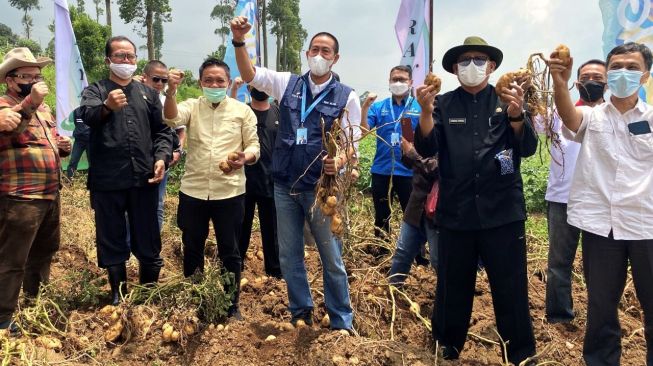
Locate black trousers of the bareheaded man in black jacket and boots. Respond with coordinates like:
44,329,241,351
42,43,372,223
91,184,163,268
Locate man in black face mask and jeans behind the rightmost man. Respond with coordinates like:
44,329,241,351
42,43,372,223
545,60,607,323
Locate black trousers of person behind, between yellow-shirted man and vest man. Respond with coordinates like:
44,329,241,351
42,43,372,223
238,193,281,277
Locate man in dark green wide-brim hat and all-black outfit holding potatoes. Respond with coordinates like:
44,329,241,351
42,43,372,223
415,37,537,365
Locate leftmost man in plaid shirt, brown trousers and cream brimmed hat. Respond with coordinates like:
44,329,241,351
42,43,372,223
0,47,70,333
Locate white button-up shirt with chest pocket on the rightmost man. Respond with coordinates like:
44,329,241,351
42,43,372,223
563,100,653,240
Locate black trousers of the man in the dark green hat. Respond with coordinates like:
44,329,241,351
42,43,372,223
432,221,535,365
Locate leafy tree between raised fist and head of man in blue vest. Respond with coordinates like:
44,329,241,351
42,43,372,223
267,0,308,73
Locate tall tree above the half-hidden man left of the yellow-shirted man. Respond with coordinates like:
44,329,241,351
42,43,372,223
118,0,172,60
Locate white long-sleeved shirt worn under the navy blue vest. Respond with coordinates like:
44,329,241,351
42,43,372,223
249,67,361,149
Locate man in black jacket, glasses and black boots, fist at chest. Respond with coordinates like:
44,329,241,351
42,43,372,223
80,36,172,303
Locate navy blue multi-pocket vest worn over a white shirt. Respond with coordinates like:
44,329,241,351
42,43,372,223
272,73,352,192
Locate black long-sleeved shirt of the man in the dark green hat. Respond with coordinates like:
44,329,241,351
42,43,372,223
415,85,537,230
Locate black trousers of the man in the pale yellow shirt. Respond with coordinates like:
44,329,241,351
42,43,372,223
177,192,245,305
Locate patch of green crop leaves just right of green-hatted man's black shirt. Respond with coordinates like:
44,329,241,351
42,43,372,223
521,147,550,213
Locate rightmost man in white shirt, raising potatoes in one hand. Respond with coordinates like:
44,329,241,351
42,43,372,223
550,42,653,366
